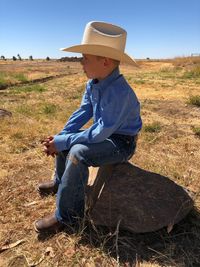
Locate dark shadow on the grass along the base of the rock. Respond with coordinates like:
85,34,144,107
80,209,200,267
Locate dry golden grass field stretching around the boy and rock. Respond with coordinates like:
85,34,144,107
0,58,200,267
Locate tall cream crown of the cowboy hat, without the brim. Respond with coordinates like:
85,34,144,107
82,21,127,52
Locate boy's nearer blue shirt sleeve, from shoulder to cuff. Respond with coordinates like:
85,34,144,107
54,87,128,151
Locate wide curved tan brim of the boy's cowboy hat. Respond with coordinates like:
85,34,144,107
60,44,137,66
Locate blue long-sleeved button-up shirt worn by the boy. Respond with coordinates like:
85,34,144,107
54,68,142,151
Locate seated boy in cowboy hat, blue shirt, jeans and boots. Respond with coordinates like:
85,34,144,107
34,22,142,232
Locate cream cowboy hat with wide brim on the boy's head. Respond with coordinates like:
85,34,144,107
60,21,136,65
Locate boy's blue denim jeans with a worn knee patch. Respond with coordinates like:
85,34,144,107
55,134,136,223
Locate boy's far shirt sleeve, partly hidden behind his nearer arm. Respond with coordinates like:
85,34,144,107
58,89,93,135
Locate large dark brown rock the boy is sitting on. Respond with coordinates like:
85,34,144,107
89,163,193,233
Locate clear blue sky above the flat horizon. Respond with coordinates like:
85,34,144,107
0,0,200,59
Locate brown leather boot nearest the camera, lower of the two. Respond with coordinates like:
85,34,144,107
34,214,64,233
